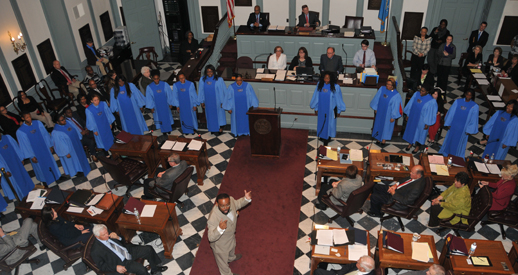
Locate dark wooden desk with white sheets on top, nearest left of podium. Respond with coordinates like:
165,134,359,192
158,136,210,185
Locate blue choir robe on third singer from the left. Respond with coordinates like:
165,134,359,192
52,121,91,177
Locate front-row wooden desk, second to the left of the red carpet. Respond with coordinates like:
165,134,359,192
58,193,124,234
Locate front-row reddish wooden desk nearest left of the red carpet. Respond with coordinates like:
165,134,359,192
117,200,182,259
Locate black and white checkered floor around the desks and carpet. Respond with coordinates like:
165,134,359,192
0,74,518,275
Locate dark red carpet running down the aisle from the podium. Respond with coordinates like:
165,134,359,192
190,129,308,275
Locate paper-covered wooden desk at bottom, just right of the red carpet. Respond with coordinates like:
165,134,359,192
310,226,372,275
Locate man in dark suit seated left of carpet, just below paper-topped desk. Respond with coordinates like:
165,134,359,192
141,153,188,200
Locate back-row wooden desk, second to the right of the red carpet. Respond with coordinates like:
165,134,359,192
366,152,415,181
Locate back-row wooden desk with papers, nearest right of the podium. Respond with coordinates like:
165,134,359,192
315,147,363,195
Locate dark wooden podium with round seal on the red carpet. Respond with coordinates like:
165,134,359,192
246,108,282,158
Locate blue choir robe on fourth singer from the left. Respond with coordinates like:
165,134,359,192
85,101,115,151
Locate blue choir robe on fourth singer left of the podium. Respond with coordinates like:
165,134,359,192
146,81,174,133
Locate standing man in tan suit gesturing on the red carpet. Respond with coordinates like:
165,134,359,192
207,190,252,275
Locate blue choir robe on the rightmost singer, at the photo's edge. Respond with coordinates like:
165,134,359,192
482,110,518,160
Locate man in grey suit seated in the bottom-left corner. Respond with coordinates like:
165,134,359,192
0,218,45,264
